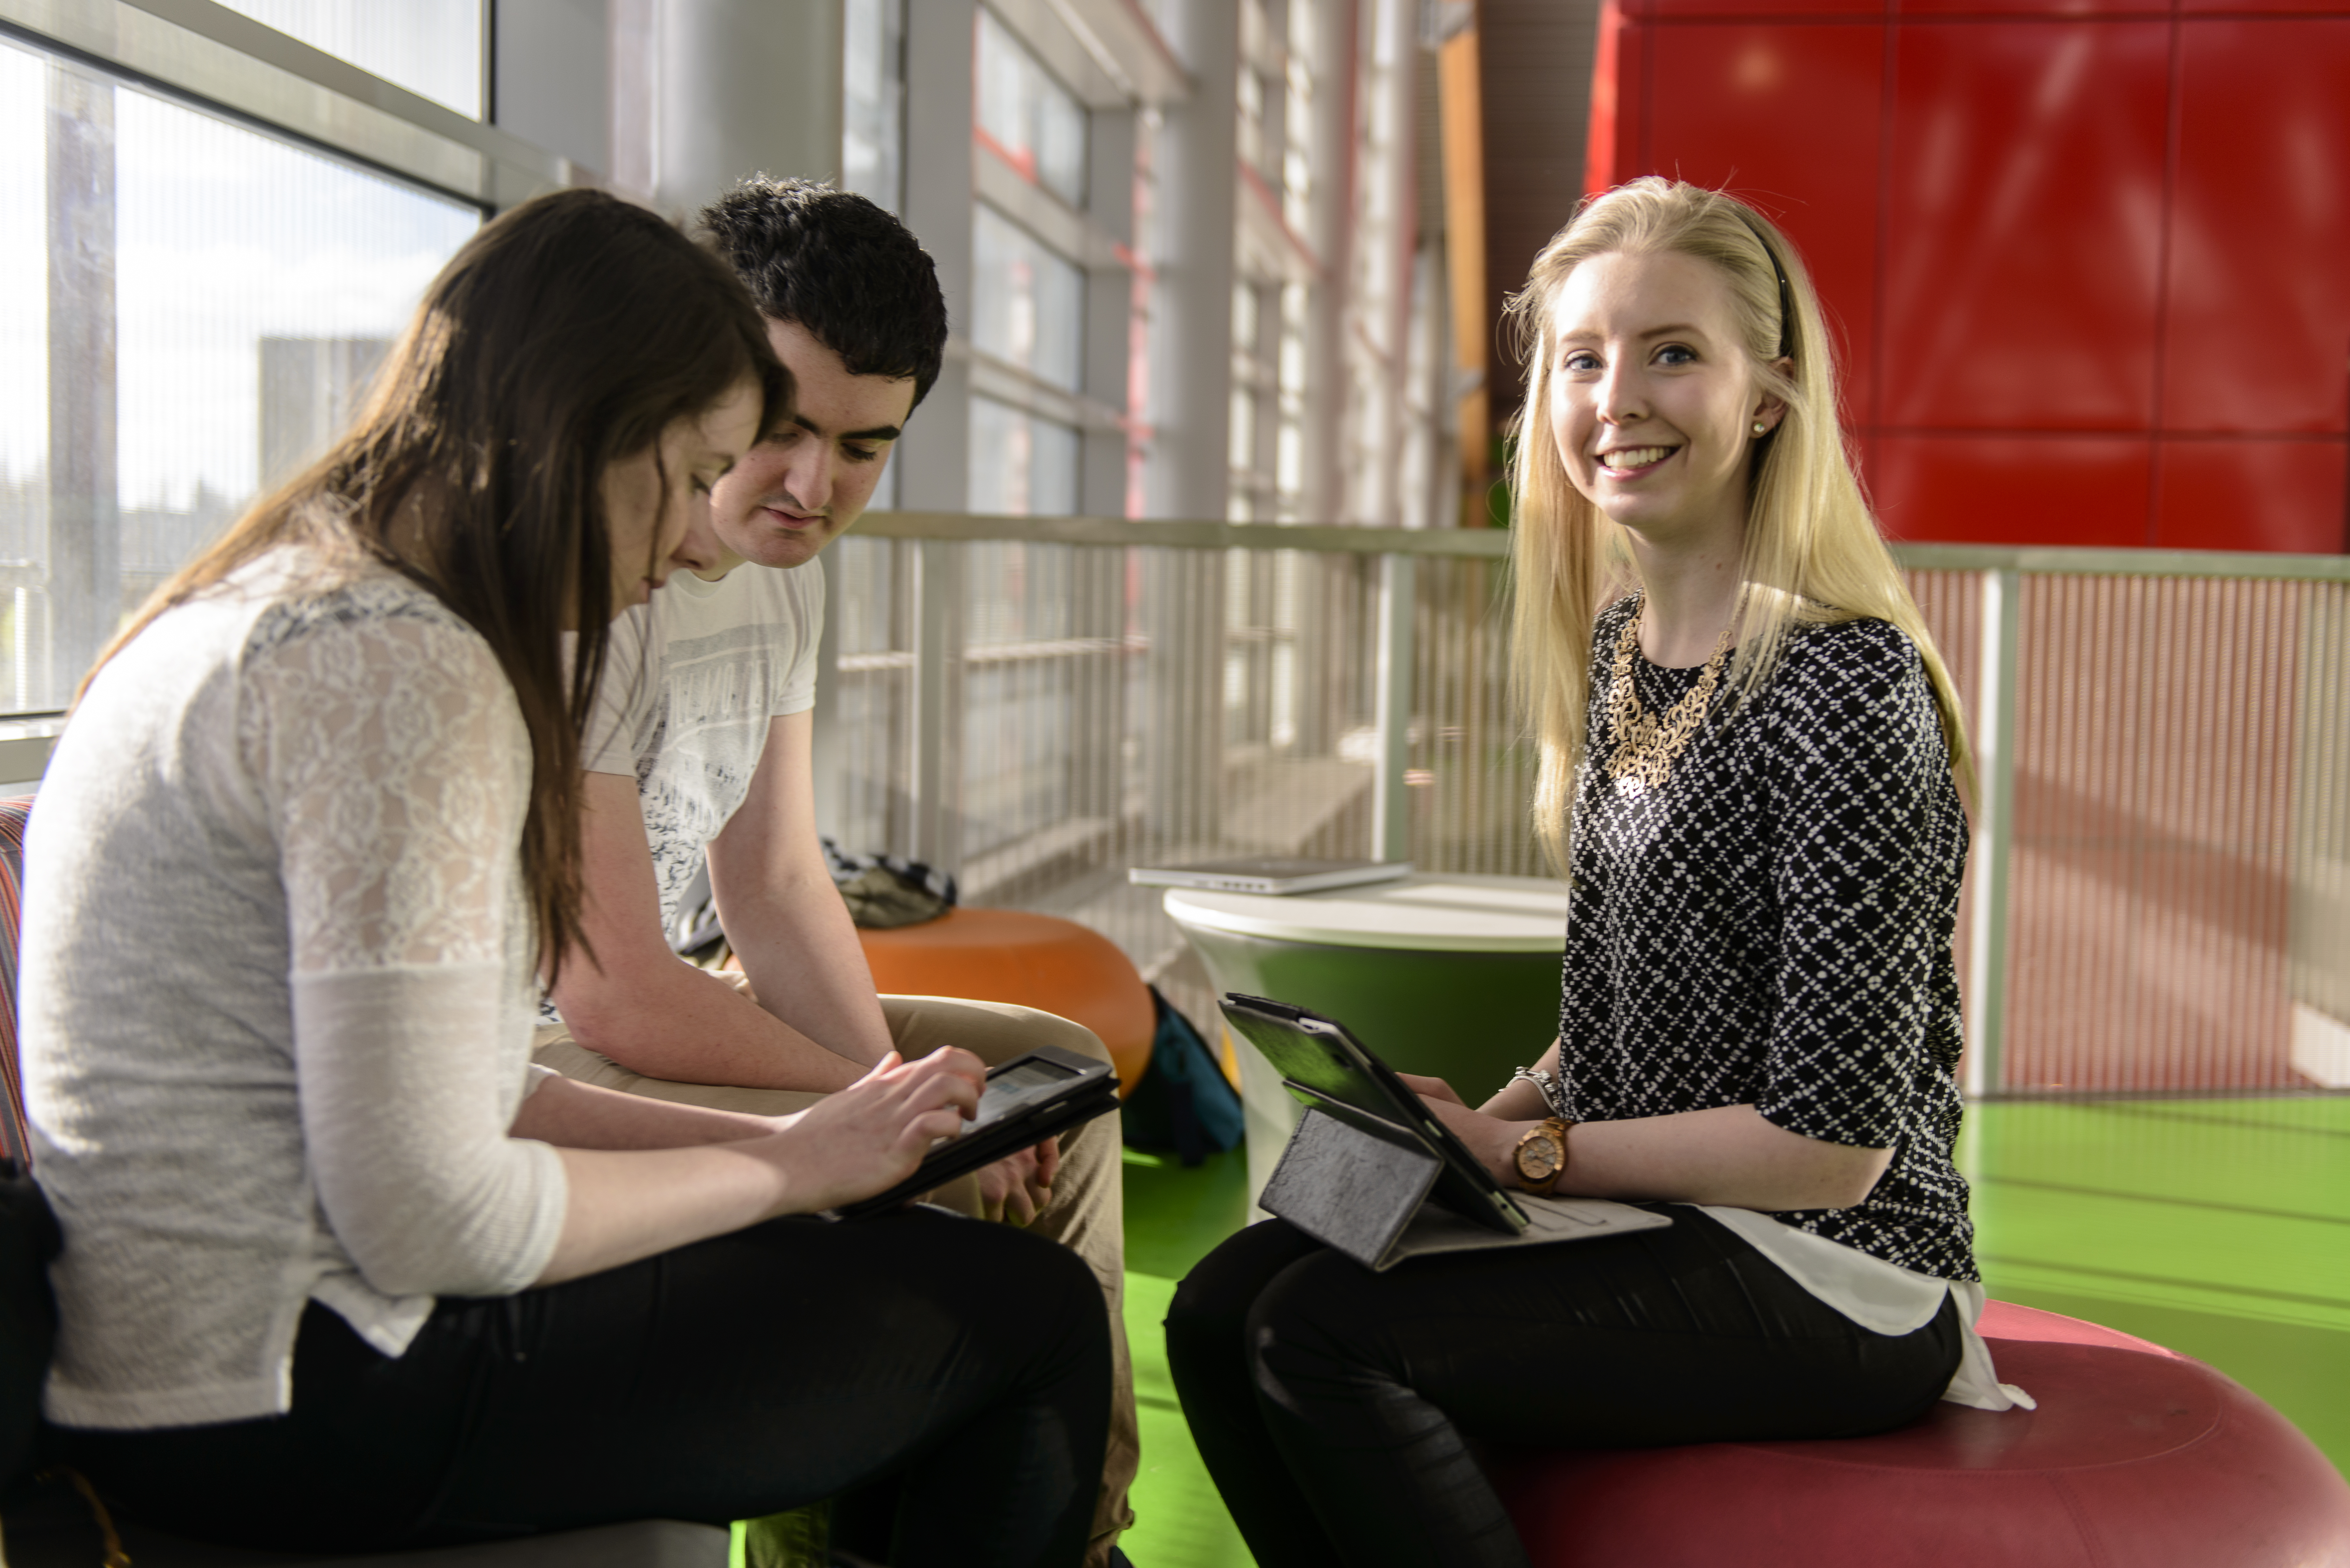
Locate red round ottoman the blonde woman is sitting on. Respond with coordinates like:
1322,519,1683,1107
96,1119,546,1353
1492,1302,2350,1568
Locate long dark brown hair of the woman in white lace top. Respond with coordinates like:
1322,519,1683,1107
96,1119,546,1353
85,191,792,980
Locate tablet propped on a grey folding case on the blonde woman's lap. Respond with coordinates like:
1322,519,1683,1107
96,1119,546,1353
1222,992,1528,1237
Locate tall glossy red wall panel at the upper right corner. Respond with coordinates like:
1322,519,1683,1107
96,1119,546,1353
2162,19,2350,433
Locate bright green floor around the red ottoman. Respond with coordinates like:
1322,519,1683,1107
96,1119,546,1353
1126,1096,2350,1568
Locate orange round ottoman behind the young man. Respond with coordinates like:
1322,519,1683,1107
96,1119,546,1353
858,908,1158,1093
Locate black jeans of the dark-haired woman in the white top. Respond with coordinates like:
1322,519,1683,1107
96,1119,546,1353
59,1208,1109,1568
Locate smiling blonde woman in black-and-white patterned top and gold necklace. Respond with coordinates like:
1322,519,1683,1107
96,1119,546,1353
1168,179,2012,1568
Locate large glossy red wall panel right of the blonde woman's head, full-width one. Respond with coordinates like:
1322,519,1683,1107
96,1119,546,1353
1880,21,2169,430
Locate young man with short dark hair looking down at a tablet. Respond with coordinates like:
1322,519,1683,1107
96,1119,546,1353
538,179,1137,1563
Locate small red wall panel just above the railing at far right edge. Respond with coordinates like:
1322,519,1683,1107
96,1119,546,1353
2155,440,2345,555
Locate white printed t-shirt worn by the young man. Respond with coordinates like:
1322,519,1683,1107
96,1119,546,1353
580,562,825,929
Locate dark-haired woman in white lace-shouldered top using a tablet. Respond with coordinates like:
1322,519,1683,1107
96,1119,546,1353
24,193,1109,1568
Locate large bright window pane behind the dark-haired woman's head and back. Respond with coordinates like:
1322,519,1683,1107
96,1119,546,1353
0,42,479,712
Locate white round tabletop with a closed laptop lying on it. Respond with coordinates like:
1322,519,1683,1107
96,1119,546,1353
1166,877,1567,952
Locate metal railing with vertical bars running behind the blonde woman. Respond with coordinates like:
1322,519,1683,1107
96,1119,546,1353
818,512,2350,1093
